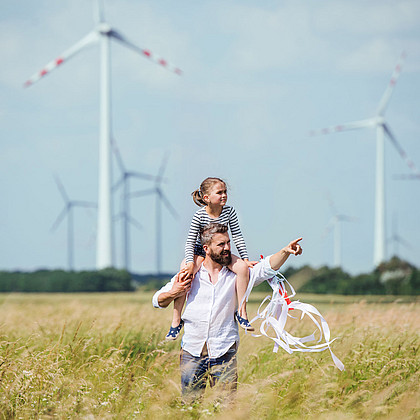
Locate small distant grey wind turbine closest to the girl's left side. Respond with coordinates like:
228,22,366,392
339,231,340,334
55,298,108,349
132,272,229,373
130,154,179,274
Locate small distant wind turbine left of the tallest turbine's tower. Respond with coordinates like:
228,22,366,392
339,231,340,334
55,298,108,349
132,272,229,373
51,176,97,271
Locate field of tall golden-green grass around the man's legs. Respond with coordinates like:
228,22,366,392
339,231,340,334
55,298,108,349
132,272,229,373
0,292,420,420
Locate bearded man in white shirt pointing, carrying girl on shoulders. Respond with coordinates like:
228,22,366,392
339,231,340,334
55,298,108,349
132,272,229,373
153,223,302,396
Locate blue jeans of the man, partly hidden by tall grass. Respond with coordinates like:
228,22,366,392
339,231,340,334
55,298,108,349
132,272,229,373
180,343,238,396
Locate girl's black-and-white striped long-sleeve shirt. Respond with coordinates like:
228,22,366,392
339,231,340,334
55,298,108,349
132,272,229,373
185,206,248,263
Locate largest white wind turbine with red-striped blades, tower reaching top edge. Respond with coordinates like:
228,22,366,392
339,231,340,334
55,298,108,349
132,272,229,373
24,0,181,269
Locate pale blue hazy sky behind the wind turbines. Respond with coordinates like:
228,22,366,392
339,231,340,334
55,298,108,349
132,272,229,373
0,0,420,274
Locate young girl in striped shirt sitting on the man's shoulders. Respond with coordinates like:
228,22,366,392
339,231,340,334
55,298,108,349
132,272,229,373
166,178,255,340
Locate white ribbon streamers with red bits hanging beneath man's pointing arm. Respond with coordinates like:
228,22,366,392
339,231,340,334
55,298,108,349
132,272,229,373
244,273,344,370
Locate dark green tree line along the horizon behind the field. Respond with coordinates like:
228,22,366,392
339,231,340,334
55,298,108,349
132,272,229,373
0,257,420,295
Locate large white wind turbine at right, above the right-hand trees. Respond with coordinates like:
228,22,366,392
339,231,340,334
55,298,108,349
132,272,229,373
310,53,420,266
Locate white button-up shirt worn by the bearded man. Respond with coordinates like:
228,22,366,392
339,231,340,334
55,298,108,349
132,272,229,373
153,257,276,358
